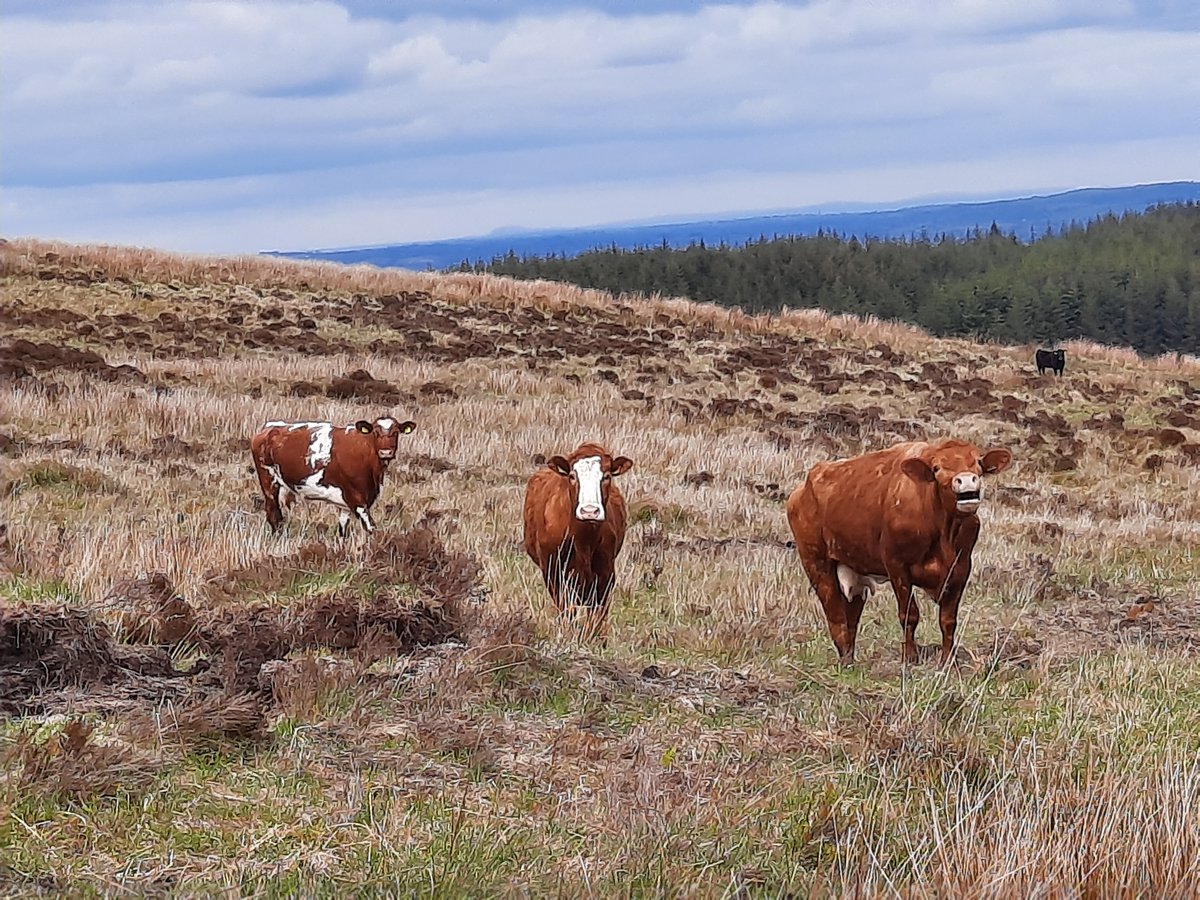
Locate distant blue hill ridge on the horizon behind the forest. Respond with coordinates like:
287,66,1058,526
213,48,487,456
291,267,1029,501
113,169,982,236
269,181,1200,270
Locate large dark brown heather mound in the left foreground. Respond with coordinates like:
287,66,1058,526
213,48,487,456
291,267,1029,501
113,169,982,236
0,528,481,715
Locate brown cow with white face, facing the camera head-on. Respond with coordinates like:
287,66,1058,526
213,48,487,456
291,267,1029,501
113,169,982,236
524,443,634,632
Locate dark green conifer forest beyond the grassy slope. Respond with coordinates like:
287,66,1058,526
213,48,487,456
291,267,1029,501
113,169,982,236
458,203,1200,354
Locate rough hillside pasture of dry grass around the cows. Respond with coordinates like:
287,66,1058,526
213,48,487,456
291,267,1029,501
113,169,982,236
0,241,1200,896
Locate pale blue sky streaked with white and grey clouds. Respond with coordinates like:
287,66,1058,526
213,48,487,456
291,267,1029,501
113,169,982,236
0,0,1200,253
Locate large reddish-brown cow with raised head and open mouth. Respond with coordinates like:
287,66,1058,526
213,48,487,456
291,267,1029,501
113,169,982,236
787,440,1013,664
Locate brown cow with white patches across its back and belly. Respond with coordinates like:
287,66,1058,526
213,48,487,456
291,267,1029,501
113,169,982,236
250,415,416,536
